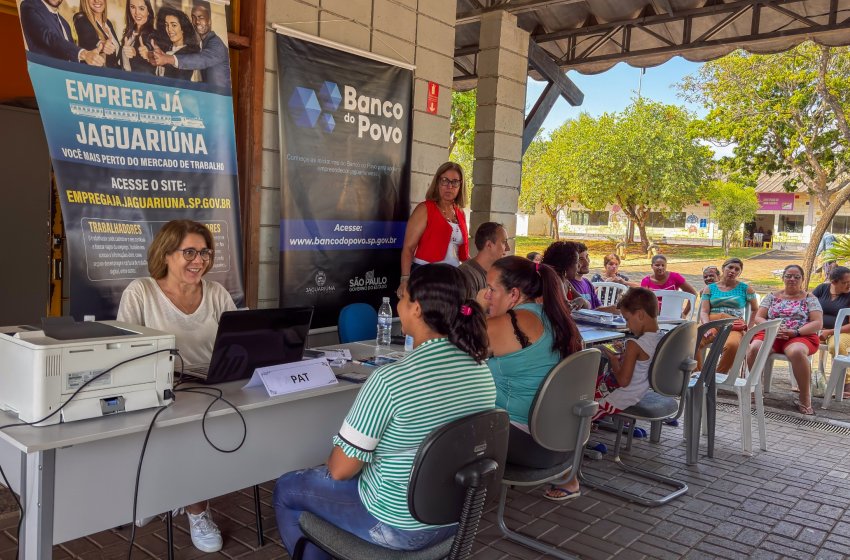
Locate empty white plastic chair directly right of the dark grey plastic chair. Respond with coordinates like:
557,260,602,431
715,319,782,455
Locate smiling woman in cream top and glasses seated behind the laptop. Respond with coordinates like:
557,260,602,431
118,220,236,552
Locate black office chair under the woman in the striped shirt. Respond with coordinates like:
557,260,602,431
292,409,510,560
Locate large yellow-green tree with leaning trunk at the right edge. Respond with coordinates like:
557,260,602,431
681,43,850,286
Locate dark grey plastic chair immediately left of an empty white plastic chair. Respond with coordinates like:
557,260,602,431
685,319,735,465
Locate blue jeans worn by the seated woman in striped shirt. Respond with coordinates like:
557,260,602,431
273,465,457,560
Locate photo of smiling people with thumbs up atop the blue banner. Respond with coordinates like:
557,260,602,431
18,0,230,88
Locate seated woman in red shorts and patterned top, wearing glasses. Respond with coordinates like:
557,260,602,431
747,264,823,415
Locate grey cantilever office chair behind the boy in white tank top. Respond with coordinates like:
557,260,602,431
579,322,697,507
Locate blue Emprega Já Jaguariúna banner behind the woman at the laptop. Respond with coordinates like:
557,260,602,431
18,0,244,319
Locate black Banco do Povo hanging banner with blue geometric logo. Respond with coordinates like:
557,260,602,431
277,28,413,327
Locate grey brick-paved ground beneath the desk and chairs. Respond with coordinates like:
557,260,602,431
0,358,850,560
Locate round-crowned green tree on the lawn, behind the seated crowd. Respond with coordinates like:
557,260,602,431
574,99,711,251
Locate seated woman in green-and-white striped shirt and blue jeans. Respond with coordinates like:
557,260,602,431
274,264,496,560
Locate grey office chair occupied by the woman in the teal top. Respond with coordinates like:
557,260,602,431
498,348,601,560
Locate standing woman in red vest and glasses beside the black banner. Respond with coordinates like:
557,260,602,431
396,161,469,298
